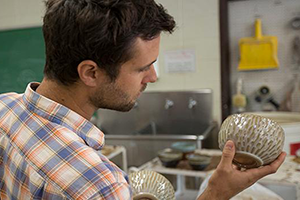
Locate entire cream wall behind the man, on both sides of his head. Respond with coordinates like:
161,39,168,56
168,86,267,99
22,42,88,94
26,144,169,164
0,0,221,121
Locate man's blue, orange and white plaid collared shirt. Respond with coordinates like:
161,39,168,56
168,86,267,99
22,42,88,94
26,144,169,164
0,83,132,200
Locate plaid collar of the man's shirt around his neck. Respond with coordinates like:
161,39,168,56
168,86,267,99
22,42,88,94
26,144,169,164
23,82,104,150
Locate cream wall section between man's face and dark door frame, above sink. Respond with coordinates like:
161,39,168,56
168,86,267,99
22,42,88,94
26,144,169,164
152,0,221,122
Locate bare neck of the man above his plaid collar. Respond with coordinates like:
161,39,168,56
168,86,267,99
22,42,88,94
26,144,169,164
36,78,96,120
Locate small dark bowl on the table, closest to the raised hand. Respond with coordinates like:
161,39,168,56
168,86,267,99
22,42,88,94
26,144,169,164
186,153,211,170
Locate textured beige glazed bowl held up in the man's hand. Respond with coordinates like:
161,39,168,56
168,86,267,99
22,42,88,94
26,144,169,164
219,114,285,168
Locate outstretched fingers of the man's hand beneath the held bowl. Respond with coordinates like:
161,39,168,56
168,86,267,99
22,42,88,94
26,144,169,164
248,152,286,179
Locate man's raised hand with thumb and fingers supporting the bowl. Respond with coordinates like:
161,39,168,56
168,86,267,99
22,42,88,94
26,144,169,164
198,141,286,200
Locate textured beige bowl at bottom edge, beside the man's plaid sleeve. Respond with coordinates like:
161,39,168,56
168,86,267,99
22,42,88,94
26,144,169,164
129,170,175,200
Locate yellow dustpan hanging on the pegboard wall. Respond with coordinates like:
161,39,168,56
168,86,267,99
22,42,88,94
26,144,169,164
238,19,279,71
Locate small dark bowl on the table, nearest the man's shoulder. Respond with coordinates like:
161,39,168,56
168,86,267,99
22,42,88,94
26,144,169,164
157,148,183,168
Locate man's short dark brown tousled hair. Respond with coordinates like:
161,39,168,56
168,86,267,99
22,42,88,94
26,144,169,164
43,0,175,85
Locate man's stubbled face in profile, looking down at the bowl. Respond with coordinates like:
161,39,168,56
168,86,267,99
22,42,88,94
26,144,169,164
90,37,160,111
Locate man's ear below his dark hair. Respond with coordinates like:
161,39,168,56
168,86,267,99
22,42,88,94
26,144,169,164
77,60,102,87
